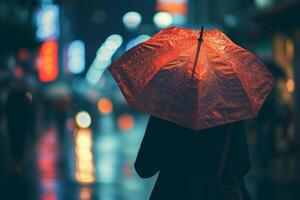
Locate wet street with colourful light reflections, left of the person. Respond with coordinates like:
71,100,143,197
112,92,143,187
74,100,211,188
0,117,155,200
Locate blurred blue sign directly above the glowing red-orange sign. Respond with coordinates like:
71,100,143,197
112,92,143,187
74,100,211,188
35,5,59,40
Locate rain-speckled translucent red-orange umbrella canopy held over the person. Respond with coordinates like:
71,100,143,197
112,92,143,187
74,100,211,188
109,27,275,130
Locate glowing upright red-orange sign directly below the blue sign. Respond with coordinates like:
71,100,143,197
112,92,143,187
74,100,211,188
38,40,58,82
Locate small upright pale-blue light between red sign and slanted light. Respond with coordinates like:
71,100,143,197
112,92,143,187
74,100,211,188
68,40,85,74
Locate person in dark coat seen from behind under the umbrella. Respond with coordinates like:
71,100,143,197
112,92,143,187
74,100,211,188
134,116,251,200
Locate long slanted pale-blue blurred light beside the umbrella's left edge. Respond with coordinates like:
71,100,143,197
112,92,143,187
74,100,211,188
86,34,123,85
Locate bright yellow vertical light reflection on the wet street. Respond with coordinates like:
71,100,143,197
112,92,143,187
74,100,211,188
74,129,95,184
